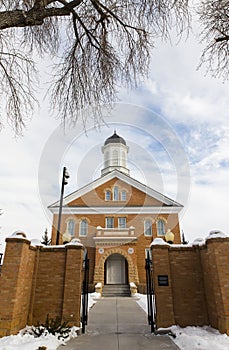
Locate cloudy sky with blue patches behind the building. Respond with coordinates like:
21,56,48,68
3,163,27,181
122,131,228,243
0,18,229,251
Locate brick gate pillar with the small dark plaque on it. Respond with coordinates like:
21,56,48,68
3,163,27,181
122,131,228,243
152,245,175,328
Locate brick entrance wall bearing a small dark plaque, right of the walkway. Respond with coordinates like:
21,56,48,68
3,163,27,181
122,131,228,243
152,238,229,334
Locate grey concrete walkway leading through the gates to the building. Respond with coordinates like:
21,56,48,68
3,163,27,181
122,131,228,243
58,297,179,350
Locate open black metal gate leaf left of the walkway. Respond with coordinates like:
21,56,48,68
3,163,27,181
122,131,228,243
81,250,89,333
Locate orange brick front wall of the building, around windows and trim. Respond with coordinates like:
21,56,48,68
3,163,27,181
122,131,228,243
49,176,180,293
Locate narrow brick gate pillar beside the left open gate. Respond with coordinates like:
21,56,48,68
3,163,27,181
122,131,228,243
62,245,84,326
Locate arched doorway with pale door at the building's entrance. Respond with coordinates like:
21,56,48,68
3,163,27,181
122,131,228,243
104,254,128,284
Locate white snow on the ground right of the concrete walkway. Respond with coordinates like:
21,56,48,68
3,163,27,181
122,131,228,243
136,294,229,350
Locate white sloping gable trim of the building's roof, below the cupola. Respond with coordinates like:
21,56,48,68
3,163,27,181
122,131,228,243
48,170,183,211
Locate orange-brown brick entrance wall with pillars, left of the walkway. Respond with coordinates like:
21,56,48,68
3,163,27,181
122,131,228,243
0,238,83,336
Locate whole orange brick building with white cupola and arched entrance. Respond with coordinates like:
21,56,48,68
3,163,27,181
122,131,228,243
49,132,182,292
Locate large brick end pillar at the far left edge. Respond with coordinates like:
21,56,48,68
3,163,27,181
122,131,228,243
0,237,36,336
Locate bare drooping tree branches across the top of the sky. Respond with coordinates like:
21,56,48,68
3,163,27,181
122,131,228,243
3,0,225,132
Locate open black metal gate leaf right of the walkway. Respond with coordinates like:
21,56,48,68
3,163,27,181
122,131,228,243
145,251,156,333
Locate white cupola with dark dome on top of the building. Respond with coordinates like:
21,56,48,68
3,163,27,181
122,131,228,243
101,131,130,175
